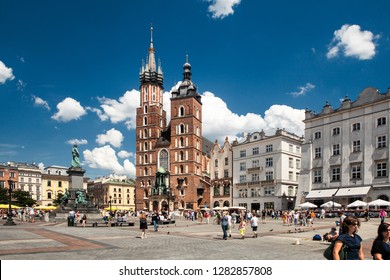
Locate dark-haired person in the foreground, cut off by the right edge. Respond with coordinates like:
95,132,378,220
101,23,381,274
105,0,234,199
371,223,390,260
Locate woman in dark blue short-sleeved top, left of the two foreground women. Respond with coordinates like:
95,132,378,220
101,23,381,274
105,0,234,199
333,216,364,260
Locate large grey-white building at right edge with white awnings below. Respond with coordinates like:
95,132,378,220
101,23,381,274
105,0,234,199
297,88,390,207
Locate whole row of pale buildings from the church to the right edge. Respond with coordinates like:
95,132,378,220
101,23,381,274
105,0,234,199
210,88,390,210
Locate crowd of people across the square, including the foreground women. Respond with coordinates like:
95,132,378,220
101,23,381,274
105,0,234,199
6,202,384,260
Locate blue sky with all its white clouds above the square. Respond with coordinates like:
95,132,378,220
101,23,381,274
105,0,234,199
0,0,390,178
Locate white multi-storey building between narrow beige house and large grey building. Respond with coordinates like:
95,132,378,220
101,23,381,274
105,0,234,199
232,129,303,211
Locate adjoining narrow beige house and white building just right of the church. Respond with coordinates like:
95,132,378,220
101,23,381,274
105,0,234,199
210,129,303,211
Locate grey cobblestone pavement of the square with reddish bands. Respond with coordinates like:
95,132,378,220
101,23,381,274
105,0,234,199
0,218,379,260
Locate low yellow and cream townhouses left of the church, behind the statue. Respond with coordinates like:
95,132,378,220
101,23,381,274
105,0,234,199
0,162,135,210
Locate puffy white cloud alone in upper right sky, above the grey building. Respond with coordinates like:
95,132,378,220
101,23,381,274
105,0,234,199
326,24,380,60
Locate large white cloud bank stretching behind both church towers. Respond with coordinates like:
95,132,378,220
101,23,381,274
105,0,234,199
92,85,304,144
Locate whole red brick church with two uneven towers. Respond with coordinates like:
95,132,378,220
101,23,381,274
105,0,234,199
136,28,213,211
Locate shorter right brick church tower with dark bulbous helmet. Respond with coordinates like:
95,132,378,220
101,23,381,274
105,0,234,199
170,56,209,209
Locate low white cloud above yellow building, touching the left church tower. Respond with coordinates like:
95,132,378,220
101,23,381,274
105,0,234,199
83,145,135,177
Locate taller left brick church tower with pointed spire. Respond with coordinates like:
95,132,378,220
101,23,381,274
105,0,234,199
135,27,166,210
